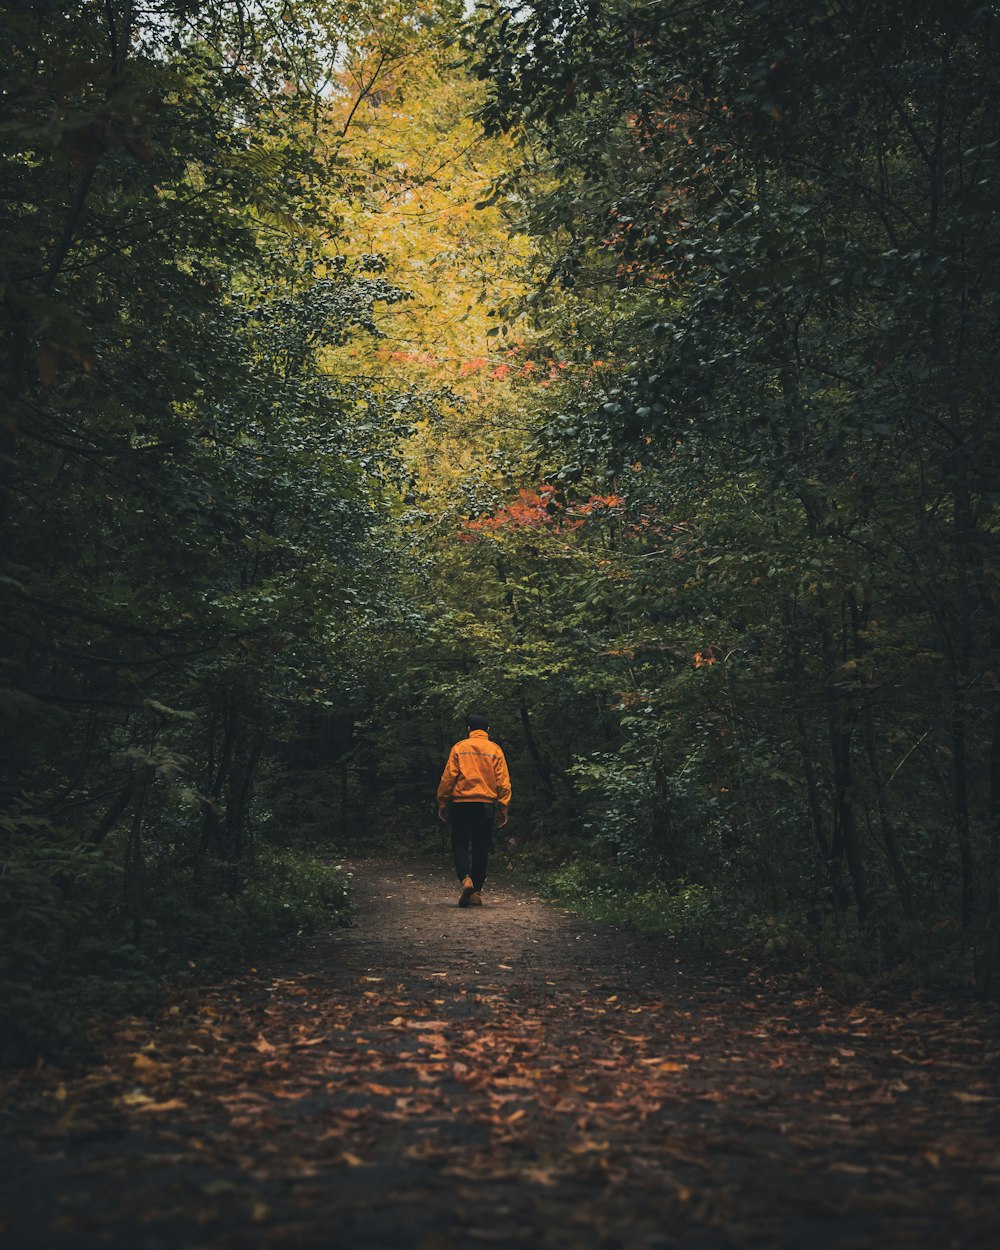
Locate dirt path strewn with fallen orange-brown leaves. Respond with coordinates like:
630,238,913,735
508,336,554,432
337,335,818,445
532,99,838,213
0,861,1000,1250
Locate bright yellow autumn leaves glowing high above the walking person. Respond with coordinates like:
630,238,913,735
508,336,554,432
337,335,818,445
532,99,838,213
315,40,530,405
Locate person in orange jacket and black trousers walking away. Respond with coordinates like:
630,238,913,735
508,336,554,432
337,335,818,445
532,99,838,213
438,716,510,908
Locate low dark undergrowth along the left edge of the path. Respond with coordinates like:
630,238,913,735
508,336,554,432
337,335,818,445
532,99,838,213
0,815,350,1064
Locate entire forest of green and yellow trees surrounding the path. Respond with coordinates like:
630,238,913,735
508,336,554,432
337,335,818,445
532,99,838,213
0,0,1000,1059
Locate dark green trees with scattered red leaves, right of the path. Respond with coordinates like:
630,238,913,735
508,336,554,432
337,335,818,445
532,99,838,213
442,0,1000,984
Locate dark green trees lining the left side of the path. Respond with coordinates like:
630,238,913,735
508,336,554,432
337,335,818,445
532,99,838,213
0,0,422,1058
